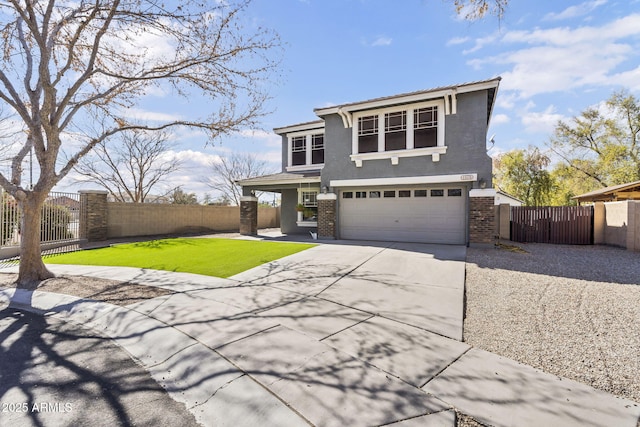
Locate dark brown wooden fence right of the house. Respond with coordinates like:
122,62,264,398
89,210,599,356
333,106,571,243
511,206,593,245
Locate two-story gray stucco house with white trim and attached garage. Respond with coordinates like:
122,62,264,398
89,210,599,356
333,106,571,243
238,78,500,244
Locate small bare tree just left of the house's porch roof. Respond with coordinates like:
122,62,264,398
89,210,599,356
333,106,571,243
204,152,271,206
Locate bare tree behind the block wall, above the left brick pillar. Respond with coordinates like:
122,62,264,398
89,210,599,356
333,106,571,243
75,130,180,203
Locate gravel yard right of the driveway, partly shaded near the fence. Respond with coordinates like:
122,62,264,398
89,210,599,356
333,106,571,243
464,242,640,402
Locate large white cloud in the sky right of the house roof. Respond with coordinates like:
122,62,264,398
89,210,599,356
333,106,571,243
468,14,640,98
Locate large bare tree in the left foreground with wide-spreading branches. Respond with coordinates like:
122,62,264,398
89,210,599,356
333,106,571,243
0,0,280,289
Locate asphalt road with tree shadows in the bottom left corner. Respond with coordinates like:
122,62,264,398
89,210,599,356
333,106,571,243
0,307,198,427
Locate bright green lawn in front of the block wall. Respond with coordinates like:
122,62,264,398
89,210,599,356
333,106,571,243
45,238,315,277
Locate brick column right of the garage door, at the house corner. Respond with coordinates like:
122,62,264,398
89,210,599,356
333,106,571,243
469,188,496,245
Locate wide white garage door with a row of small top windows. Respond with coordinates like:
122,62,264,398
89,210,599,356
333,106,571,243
339,187,467,244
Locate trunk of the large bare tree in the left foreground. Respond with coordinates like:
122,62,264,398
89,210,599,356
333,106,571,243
17,192,54,290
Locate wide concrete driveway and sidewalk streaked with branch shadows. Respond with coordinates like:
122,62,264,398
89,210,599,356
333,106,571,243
0,242,640,427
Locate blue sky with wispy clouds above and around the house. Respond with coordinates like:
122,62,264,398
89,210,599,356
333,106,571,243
59,0,640,201
